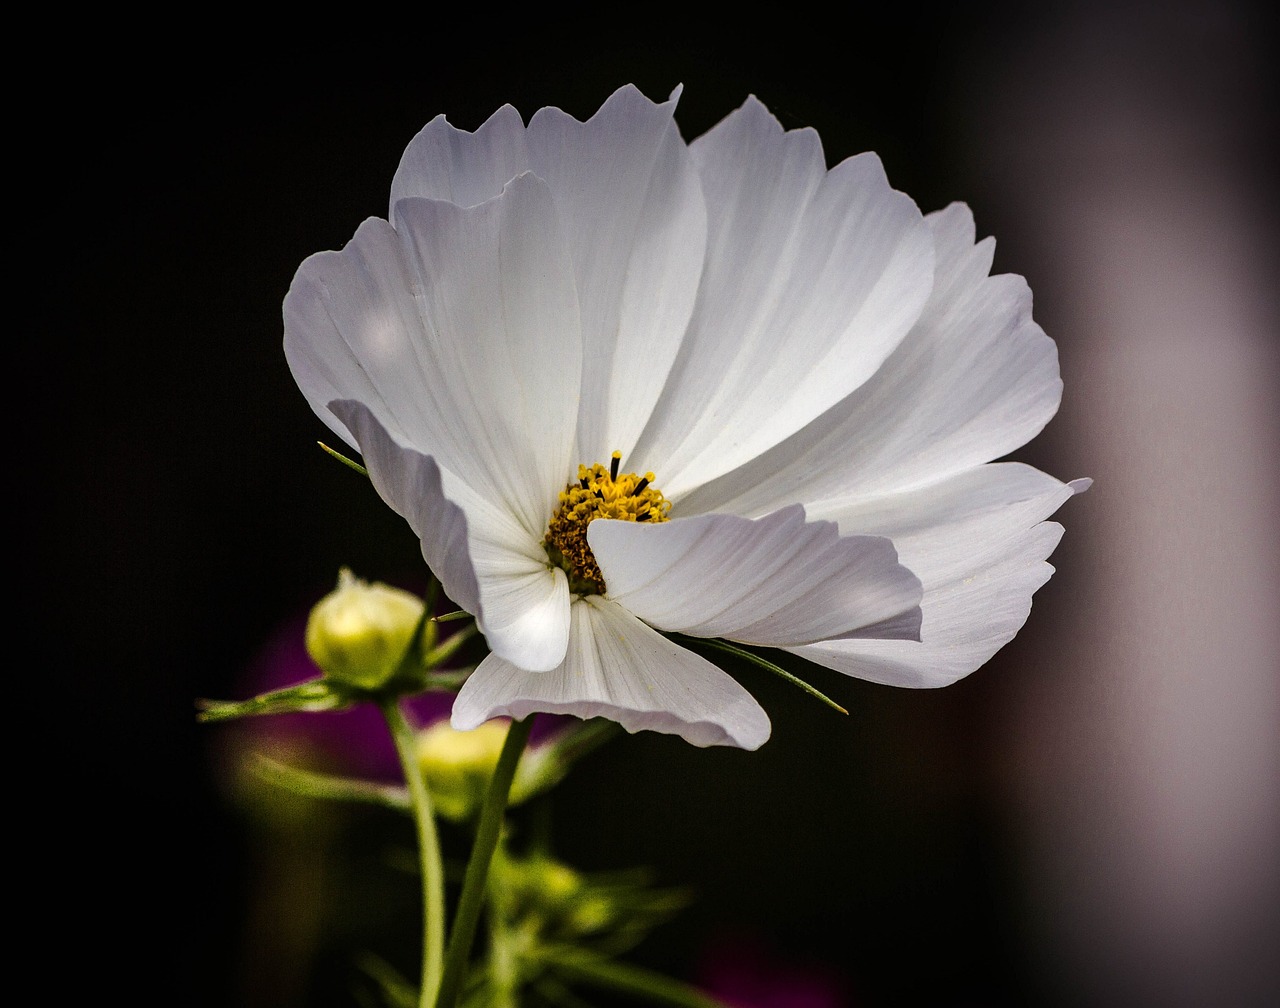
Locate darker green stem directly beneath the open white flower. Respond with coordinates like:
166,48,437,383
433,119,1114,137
435,716,534,1008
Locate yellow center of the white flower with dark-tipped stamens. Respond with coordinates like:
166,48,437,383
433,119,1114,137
544,452,671,595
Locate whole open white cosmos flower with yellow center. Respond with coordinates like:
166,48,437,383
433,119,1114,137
284,86,1087,748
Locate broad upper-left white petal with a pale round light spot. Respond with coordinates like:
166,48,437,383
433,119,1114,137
285,175,581,536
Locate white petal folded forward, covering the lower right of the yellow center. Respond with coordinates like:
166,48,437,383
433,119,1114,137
588,505,920,646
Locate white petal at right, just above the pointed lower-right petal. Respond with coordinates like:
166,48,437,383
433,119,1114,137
686,203,1062,514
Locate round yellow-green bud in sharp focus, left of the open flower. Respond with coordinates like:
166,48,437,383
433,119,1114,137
307,567,424,689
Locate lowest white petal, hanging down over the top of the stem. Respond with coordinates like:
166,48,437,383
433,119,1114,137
453,596,769,750
